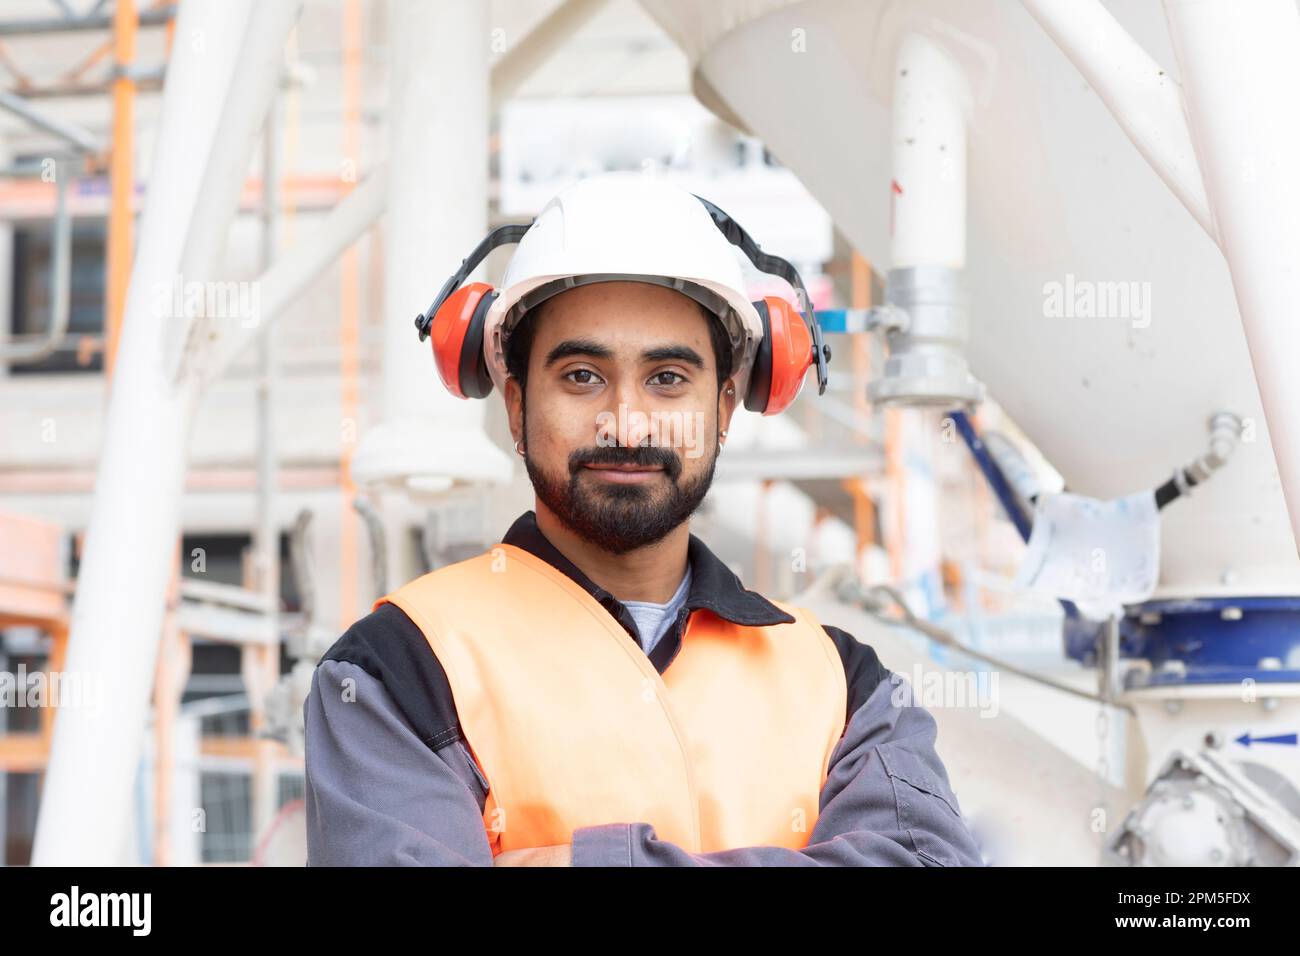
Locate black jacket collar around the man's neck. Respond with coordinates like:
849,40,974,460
502,511,794,637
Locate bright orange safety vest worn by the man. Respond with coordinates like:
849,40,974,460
376,544,848,856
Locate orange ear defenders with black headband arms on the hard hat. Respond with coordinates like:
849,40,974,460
415,195,831,415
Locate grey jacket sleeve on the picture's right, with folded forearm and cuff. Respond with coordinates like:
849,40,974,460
573,671,985,866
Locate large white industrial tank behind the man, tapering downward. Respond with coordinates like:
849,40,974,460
642,0,1300,597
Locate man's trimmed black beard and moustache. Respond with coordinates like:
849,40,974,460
523,403,718,554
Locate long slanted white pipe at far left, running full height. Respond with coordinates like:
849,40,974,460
33,0,251,865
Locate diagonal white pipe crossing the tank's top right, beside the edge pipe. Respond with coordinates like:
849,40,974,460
1022,0,1216,242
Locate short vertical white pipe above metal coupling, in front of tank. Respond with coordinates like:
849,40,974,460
889,33,970,269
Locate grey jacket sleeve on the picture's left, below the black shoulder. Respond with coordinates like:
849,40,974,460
303,661,493,866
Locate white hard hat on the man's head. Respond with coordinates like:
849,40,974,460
484,172,763,395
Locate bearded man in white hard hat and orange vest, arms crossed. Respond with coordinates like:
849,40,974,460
304,176,983,866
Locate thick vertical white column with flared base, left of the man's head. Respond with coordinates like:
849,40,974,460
352,0,514,580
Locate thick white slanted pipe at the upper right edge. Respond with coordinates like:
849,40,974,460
1165,0,1300,541
